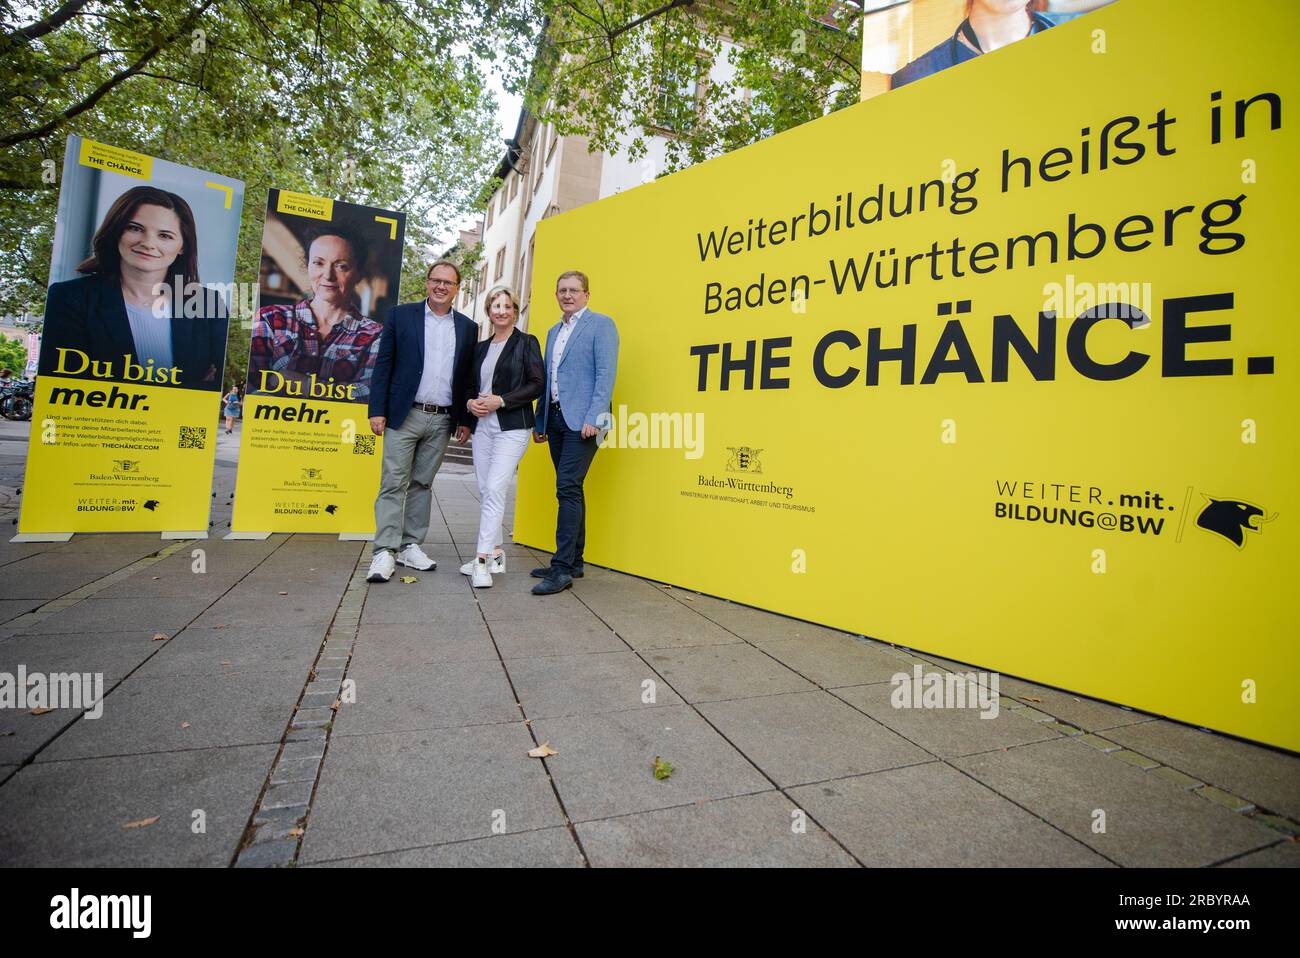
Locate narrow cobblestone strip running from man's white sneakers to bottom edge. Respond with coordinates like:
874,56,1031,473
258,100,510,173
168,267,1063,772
234,550,371,868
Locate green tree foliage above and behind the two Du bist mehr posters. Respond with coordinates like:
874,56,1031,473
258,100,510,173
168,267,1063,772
0,0,536,343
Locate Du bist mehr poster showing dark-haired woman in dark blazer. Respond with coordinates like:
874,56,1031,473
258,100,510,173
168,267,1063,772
18,136,243,537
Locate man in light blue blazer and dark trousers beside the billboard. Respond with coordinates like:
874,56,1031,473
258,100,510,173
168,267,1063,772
533,270,619,595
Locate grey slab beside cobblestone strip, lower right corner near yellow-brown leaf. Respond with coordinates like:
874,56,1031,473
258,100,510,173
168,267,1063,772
334,662,523,736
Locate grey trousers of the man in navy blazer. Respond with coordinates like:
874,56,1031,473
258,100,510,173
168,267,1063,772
374,409,451,552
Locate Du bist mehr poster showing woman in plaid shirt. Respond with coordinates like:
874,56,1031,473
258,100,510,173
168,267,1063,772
231,190,406,537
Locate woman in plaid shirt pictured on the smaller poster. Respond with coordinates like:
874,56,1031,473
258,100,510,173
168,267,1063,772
248,227,384,402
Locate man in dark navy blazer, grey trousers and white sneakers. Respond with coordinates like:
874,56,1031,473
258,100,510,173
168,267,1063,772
367,260,478,582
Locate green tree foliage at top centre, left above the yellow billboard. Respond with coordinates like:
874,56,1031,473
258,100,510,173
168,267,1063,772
527,0,862,173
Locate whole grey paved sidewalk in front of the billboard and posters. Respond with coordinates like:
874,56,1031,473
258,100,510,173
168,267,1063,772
0,424,1300,867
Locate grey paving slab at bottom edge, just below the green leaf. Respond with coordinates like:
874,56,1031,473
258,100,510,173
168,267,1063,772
577,792,857,868
